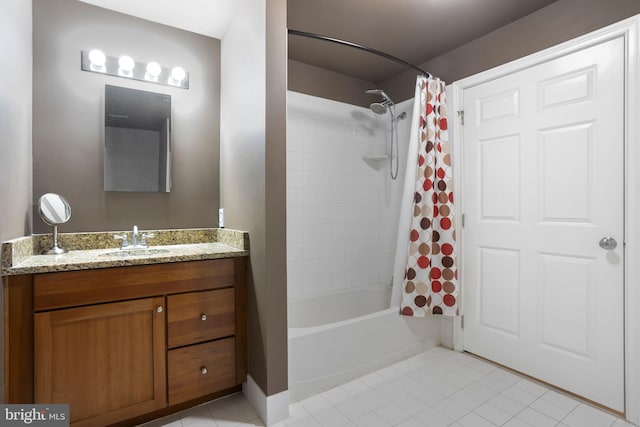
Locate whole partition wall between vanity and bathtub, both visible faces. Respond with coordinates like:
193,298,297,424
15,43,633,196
220,0,288,396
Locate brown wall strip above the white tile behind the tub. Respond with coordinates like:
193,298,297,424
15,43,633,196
288,59,377,107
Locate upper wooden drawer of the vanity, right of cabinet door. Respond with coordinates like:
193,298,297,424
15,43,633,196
167,288,236,348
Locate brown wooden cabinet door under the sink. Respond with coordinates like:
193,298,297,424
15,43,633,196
34,297,166,426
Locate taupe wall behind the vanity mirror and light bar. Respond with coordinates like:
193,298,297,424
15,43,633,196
33,0,220,232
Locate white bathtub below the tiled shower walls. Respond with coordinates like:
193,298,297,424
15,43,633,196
289,287,440,402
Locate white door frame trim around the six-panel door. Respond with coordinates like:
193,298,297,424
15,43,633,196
448,15,640,425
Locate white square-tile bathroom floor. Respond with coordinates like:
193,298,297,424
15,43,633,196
144,347,631,427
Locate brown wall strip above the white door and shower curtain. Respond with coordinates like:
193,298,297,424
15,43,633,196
381,0,640,99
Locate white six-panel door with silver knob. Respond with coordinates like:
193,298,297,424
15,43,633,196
463,38,624,412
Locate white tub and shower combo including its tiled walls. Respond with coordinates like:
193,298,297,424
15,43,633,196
287,90,442,401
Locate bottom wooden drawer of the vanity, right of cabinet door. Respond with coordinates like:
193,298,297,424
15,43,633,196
168,338,237,405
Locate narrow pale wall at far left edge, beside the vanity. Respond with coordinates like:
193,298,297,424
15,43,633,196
0,0,32,402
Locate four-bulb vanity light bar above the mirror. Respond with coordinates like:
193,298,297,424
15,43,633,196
80,49,189,89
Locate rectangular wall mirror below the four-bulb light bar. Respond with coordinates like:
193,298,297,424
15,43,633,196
104,85,171,192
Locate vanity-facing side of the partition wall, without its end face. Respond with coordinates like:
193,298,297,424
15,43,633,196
220,0,267,393
